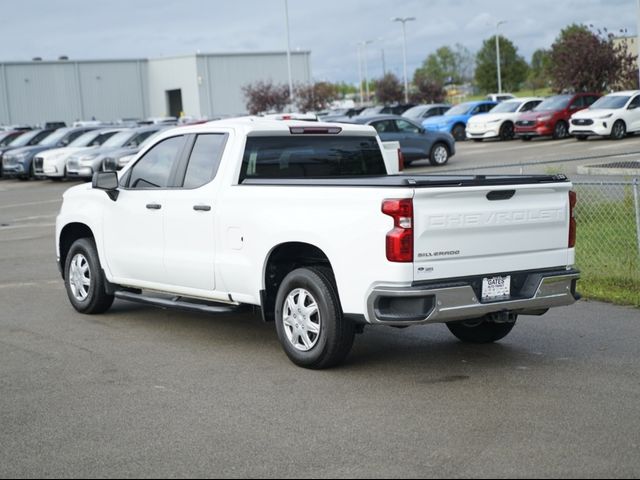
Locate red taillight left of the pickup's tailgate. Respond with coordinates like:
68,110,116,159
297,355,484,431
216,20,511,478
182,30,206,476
382,198,413,263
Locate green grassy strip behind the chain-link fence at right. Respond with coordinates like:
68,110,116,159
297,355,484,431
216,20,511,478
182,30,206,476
576,187,640,307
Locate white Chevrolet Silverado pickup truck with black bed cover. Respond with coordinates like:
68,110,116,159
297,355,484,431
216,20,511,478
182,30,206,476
56,118,579,369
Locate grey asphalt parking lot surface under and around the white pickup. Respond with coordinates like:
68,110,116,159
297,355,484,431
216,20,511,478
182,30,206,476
0,138,640,478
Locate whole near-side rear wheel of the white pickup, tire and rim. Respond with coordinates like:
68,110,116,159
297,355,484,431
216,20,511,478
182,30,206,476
275,267,355,370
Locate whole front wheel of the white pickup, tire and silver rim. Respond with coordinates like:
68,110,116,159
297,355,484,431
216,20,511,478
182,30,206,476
64,238,114,315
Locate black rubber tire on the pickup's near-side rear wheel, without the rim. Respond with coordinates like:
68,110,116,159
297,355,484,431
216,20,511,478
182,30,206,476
275,267,356,370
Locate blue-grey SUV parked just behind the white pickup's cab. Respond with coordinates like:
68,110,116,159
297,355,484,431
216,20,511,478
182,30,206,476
340,115,456,166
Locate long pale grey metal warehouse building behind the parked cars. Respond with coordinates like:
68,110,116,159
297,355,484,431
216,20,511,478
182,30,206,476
0,51,311,125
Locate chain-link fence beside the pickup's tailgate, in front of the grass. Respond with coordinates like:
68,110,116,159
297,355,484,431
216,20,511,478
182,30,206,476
436,157,640,307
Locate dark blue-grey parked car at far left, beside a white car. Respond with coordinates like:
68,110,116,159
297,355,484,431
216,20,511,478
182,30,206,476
2,127,93,180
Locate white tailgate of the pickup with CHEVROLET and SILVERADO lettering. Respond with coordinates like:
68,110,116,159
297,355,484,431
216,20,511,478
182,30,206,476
413,182,573,281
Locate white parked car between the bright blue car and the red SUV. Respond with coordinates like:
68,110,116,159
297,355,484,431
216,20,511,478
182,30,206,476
467,98,543,142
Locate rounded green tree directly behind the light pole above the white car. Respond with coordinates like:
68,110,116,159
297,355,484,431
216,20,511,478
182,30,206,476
476,35,529,92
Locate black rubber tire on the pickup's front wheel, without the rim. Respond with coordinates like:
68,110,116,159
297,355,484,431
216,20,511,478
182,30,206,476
64,238,114,315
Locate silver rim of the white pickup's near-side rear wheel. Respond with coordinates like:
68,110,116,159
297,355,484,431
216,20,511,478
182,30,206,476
282,288,322,352
